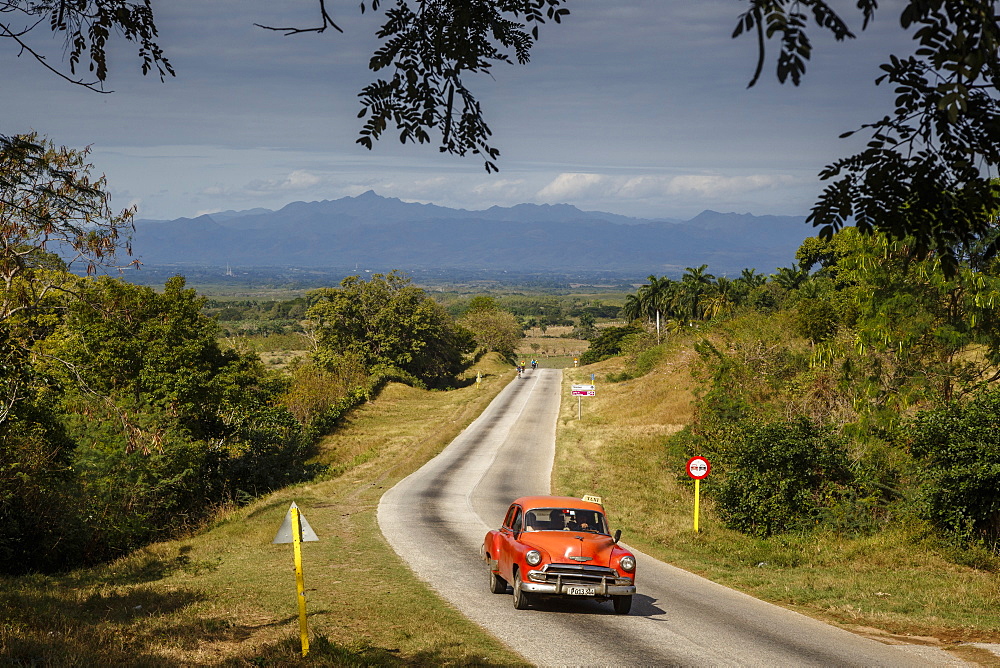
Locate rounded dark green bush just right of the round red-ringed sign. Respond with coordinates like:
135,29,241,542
715,418,851,537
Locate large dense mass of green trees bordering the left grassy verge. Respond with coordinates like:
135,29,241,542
0,277,328,572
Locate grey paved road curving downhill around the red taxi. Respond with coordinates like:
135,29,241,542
378,369,961,668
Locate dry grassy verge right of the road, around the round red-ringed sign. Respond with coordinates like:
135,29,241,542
553,345,1000,665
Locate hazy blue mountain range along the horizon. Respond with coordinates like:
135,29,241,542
132,191,813,276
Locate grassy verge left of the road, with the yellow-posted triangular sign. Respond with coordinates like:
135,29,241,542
0,352,524,666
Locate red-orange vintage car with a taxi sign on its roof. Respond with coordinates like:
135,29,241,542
482,496,635,615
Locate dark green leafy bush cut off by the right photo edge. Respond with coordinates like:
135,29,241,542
907,390,1000,551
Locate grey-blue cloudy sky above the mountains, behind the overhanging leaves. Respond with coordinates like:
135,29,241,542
0,0,908,219
